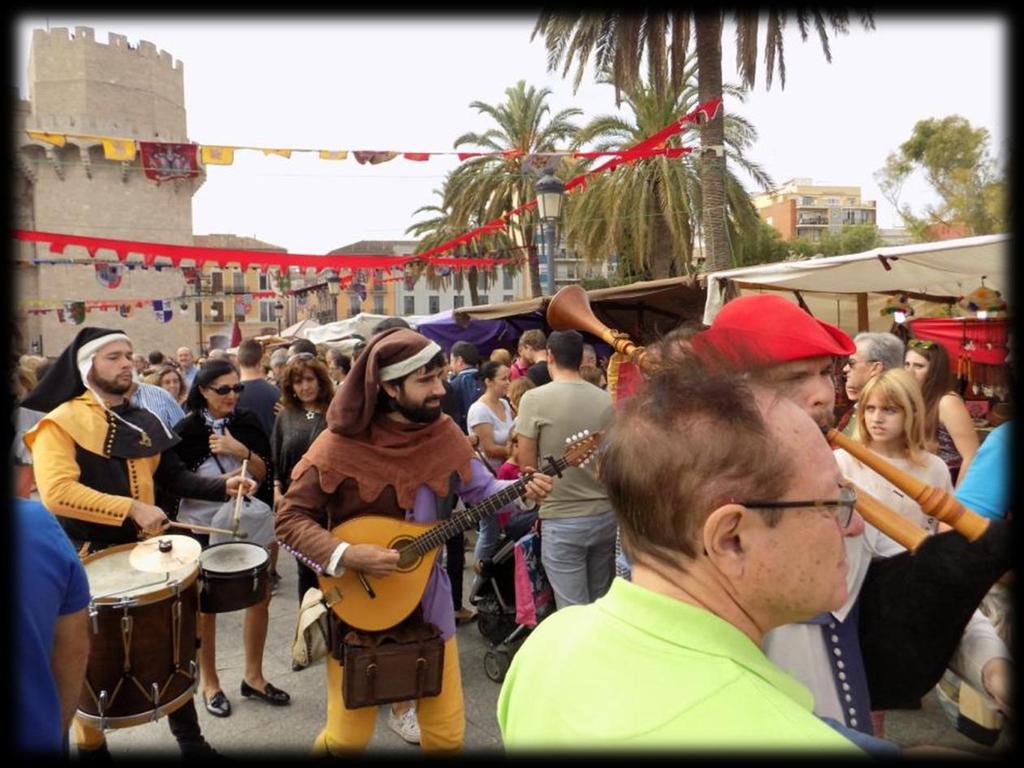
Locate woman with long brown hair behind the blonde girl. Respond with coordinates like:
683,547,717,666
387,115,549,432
903,339,979,485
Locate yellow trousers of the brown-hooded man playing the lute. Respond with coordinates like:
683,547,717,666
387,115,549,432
313,635,466,757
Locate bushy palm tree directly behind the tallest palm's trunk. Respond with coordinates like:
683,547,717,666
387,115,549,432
565,70,772,279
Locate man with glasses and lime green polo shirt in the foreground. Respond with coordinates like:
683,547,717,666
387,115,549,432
498,359,863,754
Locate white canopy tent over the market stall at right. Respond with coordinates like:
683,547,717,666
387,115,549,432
703,234,1013,332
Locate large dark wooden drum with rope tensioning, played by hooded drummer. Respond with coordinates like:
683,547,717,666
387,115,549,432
78,544,199,729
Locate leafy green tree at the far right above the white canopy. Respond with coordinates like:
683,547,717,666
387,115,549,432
874,115,1008,242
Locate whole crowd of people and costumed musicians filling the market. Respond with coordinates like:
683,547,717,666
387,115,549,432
12,296,1013,760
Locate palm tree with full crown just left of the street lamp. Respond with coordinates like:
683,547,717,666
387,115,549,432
444,80,583,297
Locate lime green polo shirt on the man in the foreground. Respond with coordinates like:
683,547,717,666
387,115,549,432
498,579,863,755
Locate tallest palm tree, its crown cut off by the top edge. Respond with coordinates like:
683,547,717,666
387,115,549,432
531,9,874,271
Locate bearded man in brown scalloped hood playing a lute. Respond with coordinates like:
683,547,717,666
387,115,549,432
275,328,552,755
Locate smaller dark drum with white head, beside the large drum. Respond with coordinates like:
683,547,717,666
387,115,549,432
199,542,270,613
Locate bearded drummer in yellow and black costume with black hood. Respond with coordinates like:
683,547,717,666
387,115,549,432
25,328,255,759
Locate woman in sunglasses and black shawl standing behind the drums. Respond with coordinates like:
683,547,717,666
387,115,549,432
165,358,290,718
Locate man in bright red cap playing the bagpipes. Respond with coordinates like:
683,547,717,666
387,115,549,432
684,295,1012,733
